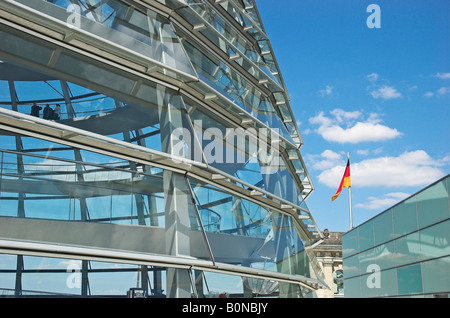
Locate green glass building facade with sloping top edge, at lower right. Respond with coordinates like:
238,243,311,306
342,176,450,298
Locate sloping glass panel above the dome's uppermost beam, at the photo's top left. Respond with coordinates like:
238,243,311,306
16,0,195,76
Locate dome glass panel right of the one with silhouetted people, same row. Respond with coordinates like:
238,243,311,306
184,98,303,205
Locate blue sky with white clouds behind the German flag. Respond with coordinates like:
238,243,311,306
256,0,450,231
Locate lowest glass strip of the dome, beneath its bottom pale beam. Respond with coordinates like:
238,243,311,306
0,254,316,298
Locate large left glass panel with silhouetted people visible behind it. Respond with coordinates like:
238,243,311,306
0,56,203,162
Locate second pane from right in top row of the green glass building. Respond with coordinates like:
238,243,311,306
392,196,418,237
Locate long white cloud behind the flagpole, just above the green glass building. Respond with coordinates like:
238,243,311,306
318,150,448,188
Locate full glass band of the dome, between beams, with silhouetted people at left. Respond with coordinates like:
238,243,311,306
0,57,306,219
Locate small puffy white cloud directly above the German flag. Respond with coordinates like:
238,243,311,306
309,109,402,144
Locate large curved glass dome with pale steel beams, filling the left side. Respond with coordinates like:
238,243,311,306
0,0,327,298
